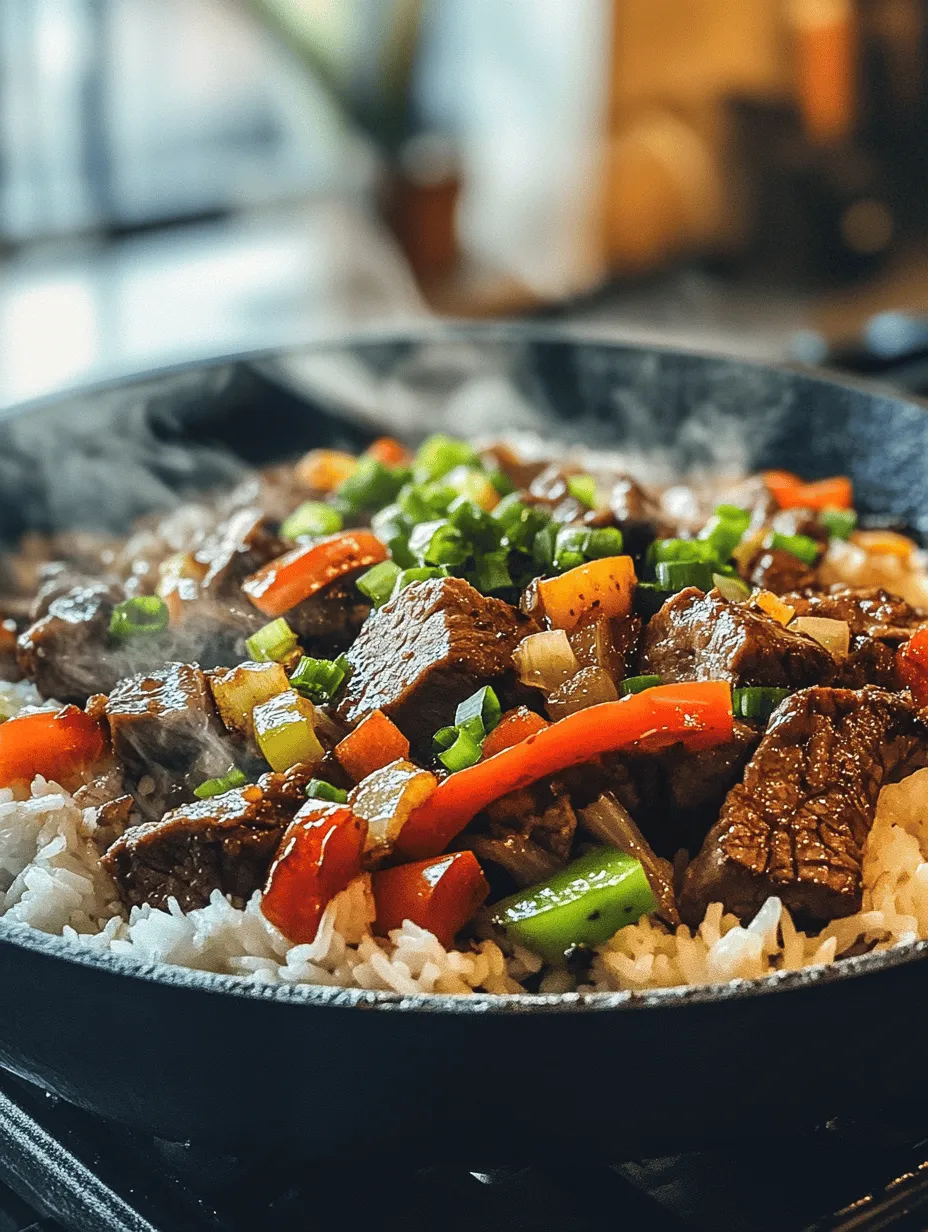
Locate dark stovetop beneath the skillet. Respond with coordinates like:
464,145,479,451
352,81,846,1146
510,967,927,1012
0,1074,928,1232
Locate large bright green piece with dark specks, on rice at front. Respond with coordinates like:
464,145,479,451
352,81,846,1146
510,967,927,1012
493,846,657,963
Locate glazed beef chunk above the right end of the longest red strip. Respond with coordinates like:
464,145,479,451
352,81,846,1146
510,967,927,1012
638,586,834,689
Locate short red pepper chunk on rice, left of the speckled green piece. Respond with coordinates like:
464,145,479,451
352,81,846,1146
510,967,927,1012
371,851,489,949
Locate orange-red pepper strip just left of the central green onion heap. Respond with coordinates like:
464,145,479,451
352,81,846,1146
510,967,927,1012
242,530,387,617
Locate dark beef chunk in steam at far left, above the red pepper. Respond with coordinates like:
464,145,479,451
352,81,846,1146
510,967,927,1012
17,582,127,706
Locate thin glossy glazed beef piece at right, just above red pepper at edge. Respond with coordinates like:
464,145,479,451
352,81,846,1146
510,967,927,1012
783,585,926,689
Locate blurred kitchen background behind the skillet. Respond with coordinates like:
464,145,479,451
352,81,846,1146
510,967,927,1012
0,0,928,405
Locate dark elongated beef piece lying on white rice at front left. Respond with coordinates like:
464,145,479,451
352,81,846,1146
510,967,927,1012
101,766,311,910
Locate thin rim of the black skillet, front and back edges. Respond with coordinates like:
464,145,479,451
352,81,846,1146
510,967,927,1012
0,320,928,1016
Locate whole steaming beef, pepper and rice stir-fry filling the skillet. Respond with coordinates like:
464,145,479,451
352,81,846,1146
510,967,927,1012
0,435,928,993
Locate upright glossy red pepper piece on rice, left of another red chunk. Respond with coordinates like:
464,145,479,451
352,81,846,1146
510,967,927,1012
261,801,367,945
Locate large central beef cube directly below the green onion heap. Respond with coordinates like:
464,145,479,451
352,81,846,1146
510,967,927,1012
339,578,537,750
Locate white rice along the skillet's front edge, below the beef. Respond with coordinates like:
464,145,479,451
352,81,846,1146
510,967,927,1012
0,770,928,994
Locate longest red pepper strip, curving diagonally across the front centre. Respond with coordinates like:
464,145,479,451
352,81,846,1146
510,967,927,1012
397,680,732,859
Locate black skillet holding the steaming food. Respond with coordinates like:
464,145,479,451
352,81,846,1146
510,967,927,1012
0,326,928,1163
